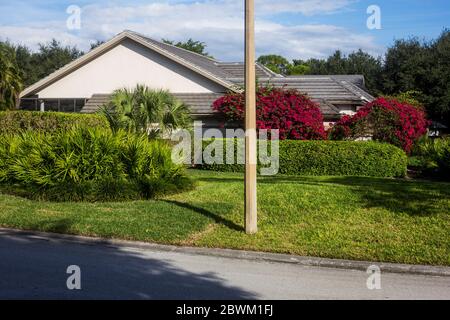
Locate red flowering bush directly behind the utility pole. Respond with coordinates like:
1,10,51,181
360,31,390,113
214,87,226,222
213,87,326,140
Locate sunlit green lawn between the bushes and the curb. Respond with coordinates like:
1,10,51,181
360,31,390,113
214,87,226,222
0,171,450,265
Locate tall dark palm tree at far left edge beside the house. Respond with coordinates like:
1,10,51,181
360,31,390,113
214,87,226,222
0,45,22,110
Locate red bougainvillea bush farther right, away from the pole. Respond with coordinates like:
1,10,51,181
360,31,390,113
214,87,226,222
329,98,429,153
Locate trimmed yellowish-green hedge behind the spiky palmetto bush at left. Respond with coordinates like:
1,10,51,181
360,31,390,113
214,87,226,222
0,111,109,134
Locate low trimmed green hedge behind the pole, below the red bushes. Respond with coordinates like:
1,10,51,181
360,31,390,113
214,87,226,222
199,140,408,177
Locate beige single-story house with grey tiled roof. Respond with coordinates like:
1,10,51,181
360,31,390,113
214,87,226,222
20,31,374,127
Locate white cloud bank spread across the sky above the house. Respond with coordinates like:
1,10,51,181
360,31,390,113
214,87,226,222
0,0,381,61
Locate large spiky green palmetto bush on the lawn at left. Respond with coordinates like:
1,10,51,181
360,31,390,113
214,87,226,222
0,127,191,201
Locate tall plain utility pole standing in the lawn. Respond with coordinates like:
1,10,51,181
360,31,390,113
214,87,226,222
245,0,258,234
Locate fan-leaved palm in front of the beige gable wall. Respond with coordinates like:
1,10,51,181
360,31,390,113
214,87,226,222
100,85,192,136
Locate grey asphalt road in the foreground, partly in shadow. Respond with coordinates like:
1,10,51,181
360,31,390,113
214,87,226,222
0,232,450,300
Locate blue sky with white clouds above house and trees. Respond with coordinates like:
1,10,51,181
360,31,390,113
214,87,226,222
0,0,450,61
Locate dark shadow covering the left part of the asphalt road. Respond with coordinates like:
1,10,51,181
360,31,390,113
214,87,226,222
0,228,258,300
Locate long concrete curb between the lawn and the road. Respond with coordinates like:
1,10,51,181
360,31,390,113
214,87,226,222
0,228,450,277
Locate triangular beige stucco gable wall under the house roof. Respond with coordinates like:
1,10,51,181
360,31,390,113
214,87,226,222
38,40,226,98
